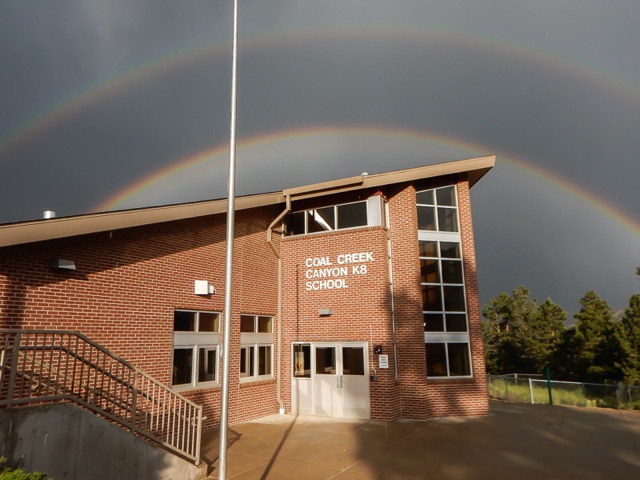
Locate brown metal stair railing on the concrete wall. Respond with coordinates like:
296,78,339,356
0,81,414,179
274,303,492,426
0,330,202,465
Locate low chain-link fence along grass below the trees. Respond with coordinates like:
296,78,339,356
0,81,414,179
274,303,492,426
487,374,640,410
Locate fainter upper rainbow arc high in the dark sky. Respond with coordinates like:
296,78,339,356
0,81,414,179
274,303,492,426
0,26,640,162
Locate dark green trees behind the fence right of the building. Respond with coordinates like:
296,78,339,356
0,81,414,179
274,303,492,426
482,267,640,386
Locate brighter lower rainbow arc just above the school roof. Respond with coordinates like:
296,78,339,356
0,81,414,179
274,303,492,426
94,126,640,236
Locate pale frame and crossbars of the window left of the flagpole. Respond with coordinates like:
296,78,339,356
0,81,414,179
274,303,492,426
171,308,221,391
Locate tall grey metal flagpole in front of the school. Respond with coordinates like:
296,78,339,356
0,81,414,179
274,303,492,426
218,0,238,480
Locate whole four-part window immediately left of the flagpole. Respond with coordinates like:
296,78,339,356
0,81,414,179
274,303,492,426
171,310,220,389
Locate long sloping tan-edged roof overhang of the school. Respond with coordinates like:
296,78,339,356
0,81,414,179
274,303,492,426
0,155,496,247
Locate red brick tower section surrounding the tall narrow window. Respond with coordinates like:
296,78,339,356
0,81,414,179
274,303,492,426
390,180,488,419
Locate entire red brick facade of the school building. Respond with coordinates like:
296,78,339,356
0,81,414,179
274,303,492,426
0,164,487,427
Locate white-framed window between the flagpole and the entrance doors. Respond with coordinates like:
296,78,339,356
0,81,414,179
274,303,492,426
240,315,273,381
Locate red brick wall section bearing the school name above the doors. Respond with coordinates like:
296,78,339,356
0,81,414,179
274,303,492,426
281,221,399,420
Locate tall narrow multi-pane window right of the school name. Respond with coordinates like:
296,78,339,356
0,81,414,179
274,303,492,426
416,186,471,377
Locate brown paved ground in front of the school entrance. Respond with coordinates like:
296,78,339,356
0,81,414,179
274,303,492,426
205,402,640,480
